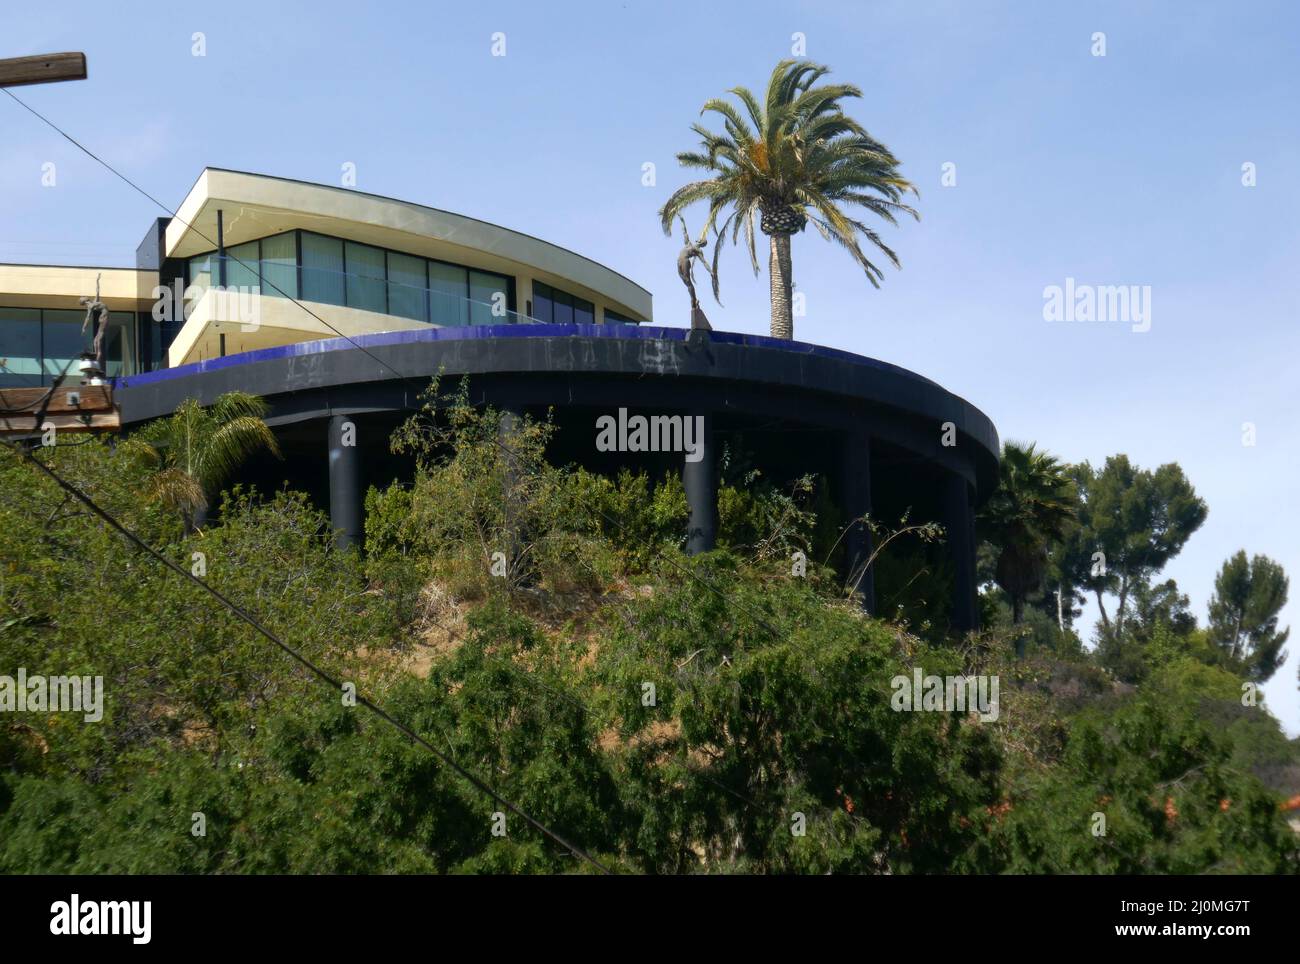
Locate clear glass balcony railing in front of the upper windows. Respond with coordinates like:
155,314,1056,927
191,257,541,327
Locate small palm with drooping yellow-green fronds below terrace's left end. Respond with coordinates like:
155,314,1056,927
122,391,280,533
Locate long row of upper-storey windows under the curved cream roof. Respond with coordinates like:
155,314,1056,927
186,231,512,326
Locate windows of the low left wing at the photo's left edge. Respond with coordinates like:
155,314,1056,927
0,307,139,388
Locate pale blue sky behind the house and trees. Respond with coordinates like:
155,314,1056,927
0,0,1300,735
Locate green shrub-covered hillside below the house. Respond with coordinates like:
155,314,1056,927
0,387,1300,873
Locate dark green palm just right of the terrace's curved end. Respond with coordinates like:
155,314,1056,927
979,442,1078,624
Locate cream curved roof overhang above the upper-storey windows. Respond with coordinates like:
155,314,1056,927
165,168,651,318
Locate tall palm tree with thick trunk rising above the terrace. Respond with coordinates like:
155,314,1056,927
659,60,920,339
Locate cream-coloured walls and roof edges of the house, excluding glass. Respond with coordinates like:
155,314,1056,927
0,168,653,370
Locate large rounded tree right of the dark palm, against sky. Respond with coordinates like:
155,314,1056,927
1063,455,1209,638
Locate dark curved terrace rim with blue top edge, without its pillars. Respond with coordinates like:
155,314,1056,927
117,325,1000,498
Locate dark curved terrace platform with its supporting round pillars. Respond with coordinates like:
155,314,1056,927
117,325,998,631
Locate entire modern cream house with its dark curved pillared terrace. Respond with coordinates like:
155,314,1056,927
0,168,998,629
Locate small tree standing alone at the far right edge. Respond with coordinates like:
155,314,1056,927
1210,550,1291,683
